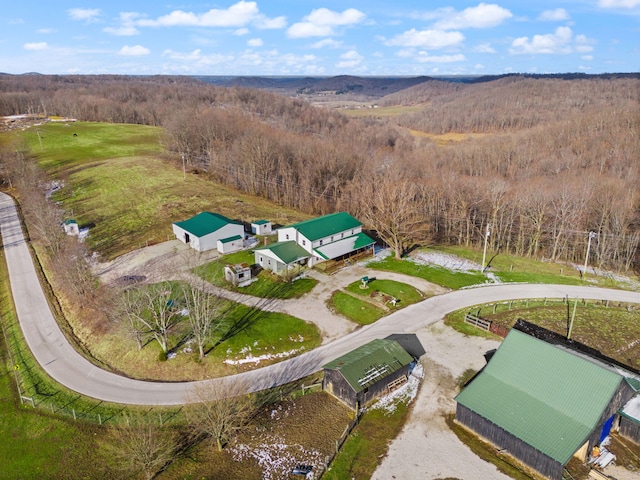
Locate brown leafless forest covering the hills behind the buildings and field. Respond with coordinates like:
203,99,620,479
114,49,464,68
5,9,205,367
0,75,640,270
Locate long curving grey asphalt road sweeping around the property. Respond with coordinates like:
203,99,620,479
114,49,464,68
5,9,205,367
0,193,640,405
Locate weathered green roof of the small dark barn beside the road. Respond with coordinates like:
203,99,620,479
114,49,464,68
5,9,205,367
322,339,413,392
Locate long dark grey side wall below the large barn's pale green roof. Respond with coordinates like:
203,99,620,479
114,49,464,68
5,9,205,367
456,403,564,480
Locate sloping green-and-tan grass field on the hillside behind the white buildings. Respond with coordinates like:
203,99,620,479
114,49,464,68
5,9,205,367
19,123,303,260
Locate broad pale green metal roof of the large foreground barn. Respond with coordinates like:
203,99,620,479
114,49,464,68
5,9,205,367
456,329,623,465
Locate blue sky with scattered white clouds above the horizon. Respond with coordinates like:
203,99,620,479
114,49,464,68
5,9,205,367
0,0,640,76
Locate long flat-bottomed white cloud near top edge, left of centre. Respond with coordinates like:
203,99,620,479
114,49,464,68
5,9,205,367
137,0,286,29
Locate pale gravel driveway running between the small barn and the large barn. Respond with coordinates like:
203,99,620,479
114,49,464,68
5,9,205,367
372,322,510,480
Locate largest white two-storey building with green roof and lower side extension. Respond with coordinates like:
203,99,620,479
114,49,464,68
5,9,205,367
278,212,375,266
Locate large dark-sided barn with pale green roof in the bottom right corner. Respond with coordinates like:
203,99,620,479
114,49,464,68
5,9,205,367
455,329,636,479
